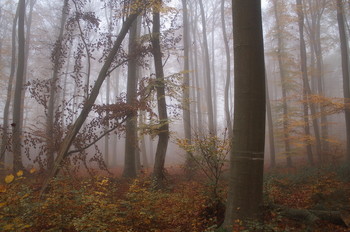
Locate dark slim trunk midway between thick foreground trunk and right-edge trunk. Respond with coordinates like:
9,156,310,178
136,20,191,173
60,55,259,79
296,0,314,165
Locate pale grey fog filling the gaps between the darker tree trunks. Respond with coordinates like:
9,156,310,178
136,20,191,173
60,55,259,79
0,0,349,175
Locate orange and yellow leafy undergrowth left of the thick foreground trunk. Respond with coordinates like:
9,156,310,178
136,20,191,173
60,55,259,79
0,172,219,231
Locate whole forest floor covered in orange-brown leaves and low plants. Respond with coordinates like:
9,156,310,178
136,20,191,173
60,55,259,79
0,162,350,232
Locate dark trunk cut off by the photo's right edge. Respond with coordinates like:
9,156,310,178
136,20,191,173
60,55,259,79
336,0,350,163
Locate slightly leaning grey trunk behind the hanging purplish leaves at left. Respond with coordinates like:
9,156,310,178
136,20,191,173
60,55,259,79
46,0,68,170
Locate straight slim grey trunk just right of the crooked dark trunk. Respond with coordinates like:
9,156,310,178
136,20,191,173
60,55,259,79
182,0,193,178
